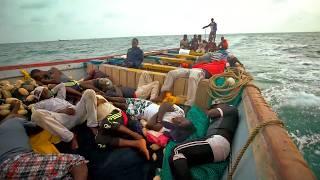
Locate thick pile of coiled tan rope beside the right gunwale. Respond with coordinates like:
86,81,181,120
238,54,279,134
208,67,253,103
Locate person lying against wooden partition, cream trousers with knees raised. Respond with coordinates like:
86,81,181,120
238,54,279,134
88,71,160,100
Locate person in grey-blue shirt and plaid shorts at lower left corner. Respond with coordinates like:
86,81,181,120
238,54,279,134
0,101,88,180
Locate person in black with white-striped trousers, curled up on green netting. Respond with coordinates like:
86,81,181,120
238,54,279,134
170,104,239,180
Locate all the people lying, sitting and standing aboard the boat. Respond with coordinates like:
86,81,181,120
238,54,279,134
0,16,241,179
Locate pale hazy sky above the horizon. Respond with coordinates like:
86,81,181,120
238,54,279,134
0,0,320,43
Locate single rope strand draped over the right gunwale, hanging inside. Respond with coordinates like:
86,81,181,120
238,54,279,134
228,120,284,180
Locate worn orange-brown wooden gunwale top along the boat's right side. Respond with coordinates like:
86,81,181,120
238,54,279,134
243,86,315,180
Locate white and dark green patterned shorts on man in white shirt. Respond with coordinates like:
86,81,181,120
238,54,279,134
126,98,152,120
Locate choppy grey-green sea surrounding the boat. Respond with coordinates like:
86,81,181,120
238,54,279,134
0,33,320,178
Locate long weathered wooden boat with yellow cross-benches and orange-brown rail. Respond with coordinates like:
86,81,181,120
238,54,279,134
0,48,315,180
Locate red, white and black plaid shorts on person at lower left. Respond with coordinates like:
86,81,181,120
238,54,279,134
0,152,88,179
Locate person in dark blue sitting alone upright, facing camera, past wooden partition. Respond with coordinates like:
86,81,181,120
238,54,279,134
124,38,143,68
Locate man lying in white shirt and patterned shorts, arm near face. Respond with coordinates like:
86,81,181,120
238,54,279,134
105,97,195,141
